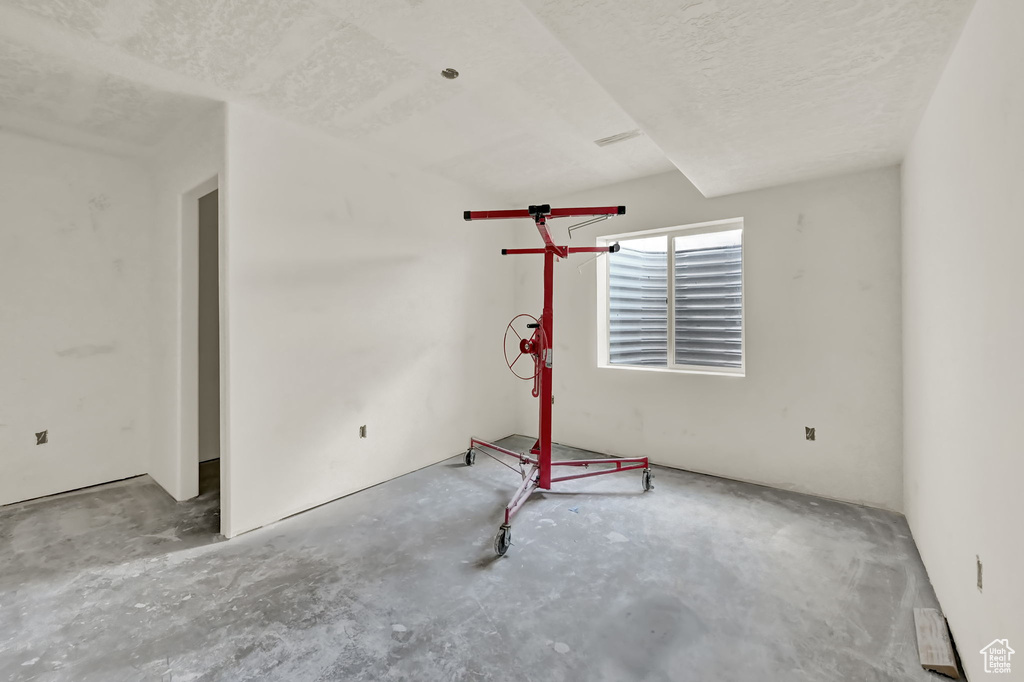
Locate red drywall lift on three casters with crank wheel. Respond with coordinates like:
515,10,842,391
463,204,652,555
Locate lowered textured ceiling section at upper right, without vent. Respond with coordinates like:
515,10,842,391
523,0,974,196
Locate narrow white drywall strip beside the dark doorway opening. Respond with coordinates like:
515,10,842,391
147,106,228,499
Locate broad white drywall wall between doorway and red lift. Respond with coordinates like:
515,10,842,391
220,104,515,536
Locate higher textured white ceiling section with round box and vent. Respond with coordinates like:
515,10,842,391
0,0,672,197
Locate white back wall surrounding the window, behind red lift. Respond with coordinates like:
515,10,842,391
509,168,902,510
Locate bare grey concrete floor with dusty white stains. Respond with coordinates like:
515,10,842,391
0,437,937,682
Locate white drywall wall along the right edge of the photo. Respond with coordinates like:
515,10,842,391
903,0,1024,679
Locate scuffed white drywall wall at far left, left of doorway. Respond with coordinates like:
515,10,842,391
0,131,153,504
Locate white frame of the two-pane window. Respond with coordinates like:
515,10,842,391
597,217,746,377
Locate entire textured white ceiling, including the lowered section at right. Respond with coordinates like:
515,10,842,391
0,0,973,196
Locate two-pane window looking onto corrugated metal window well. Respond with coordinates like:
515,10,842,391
598,218,743,375
